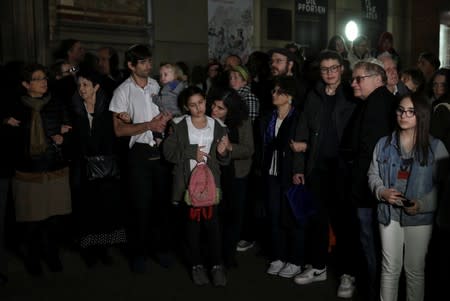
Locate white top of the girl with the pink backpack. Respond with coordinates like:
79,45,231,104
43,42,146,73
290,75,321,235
186,116,214,170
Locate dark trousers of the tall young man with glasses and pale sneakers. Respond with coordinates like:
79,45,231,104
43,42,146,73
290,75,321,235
306,159,360,275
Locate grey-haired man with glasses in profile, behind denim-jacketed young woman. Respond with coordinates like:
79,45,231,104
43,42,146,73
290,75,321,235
349,58,397,300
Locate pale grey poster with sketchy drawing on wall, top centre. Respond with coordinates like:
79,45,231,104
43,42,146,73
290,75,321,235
208,0,253,62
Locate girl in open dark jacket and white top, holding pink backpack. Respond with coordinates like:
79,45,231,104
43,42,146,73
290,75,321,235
163,86,230,286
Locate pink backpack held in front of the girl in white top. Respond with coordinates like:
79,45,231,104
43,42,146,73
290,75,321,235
185,162,218,207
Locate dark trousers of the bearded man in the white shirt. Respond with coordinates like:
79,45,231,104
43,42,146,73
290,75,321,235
127,143,171,257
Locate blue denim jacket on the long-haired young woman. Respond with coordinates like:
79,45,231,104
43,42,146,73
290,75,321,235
367,132,448,226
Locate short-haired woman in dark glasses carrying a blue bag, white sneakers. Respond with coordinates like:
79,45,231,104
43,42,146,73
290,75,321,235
261,77,303,278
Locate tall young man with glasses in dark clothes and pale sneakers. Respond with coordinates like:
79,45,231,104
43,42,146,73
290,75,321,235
292,50,358,298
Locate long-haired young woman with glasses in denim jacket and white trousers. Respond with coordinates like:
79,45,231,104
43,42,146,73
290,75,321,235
368,94,448,301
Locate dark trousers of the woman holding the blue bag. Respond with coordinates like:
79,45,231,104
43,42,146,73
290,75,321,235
266,176,304,265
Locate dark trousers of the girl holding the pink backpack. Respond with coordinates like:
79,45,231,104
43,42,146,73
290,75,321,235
186,206,222,266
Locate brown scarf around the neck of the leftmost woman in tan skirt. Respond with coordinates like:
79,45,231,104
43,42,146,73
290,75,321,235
22,95,50,156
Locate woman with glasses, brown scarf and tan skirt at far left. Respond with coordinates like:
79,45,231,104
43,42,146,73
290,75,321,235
11,64,72,275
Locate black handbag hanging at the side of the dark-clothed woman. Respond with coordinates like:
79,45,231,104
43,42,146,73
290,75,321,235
85,155,120,181
